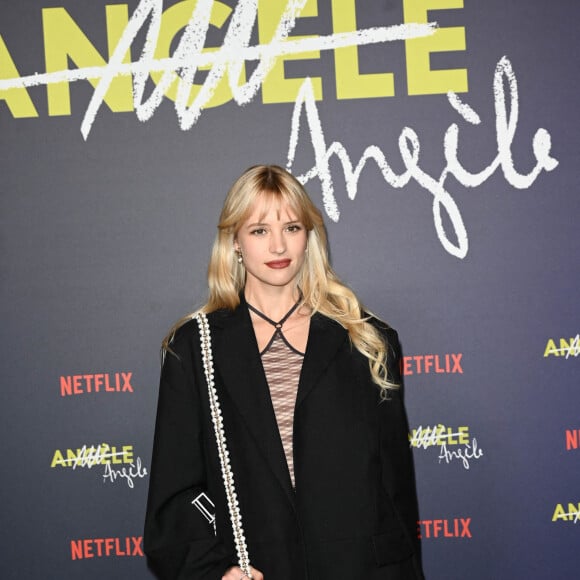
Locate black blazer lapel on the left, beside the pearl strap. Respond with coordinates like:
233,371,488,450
210,306,294,503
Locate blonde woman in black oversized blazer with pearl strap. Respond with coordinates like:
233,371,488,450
145,166,421,580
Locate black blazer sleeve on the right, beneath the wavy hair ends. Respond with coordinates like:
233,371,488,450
380,328,423,578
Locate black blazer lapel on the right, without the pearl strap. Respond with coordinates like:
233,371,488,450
295,313,348,412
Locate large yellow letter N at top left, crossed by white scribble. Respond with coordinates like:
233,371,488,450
42,4,133,116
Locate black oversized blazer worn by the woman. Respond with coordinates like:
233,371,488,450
144,299,421,580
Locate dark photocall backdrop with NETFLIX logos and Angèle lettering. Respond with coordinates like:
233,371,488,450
0,0,580,580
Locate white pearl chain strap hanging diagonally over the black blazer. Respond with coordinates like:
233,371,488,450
195,312,252,579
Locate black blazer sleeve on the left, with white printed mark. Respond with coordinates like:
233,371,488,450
144,330,235,580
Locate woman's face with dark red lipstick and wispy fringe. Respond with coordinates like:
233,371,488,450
234,198,308,290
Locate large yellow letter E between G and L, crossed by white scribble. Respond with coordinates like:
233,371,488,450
258,0,322,103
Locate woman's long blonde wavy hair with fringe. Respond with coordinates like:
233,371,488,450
163,165,398,397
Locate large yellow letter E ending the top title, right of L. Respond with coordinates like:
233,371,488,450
403,0,467,95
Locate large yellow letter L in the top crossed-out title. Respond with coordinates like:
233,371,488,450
332,0,395,99
